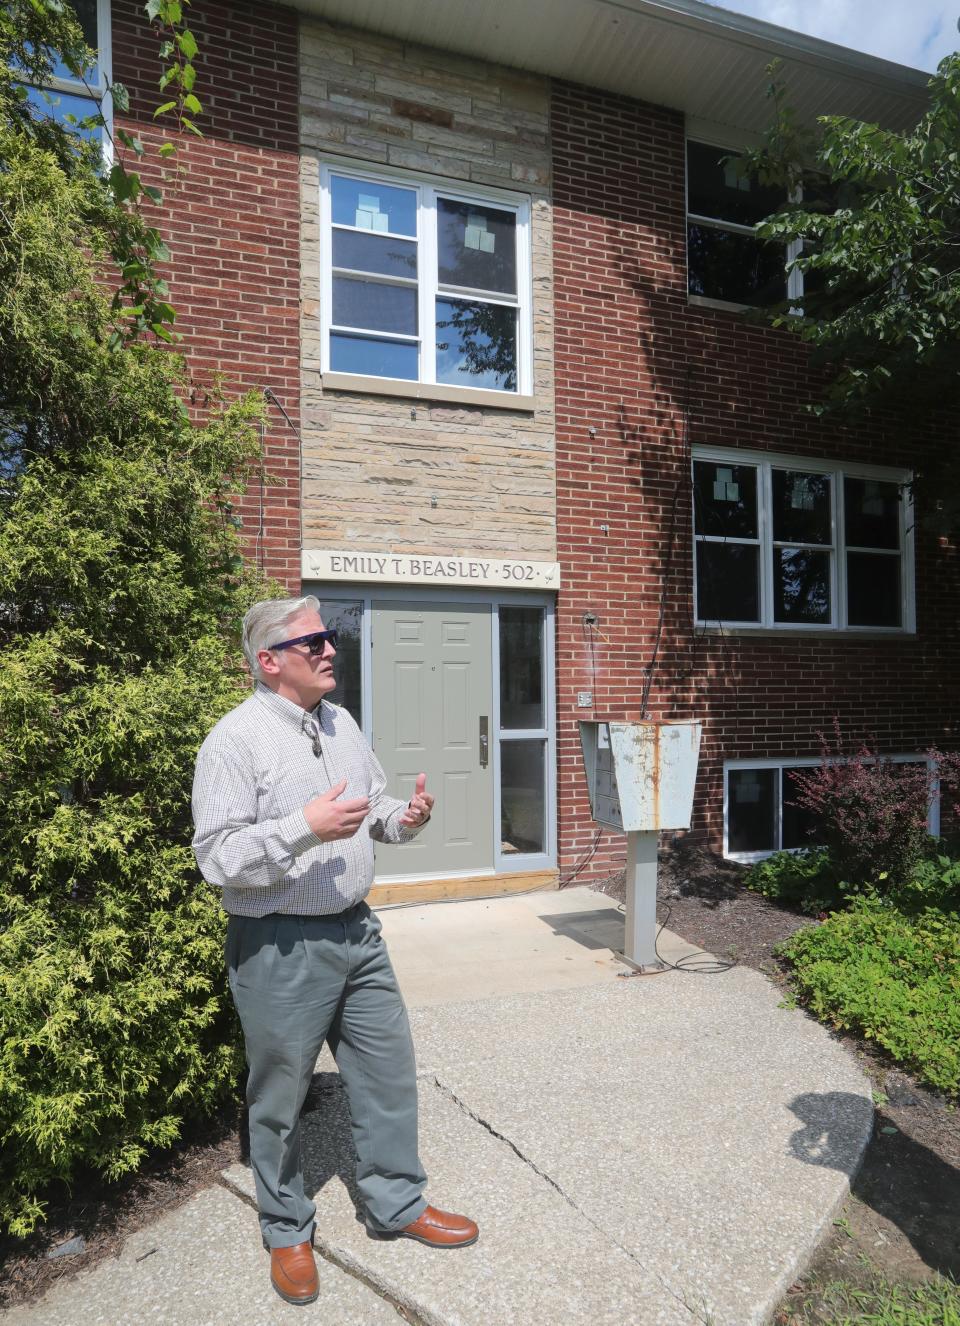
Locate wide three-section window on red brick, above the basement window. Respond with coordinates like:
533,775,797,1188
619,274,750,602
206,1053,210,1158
693,447,914,631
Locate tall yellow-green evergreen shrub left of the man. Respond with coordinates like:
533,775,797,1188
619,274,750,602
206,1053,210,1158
0,5,260,1235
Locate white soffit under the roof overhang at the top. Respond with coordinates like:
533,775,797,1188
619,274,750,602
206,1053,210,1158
294,0,930,131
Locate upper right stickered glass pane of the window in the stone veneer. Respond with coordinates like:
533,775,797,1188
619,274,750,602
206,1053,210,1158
436,198,517,294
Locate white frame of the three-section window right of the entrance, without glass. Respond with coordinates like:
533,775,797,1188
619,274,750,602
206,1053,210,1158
691,446,916,635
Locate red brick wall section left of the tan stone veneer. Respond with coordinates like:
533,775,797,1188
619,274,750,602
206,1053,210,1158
113,0,300,591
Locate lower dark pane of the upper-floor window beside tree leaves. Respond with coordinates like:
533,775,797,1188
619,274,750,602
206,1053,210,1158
687,229,786,308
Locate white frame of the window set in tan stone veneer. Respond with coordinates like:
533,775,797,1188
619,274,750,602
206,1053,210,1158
320,160,533,397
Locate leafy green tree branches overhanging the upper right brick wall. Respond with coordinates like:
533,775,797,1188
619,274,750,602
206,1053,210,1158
745,53,960,521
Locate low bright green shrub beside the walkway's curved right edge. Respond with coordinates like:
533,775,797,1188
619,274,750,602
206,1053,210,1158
777,896,960,1094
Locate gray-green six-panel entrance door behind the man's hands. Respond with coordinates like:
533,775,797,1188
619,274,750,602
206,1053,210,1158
373,602,493,878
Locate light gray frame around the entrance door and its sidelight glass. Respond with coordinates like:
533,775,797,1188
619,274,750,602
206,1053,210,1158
301,581,557,882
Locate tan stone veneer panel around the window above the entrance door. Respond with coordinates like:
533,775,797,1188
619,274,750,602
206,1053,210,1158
300,19,557,561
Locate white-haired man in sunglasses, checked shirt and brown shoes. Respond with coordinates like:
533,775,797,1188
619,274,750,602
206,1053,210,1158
194,597,479,1303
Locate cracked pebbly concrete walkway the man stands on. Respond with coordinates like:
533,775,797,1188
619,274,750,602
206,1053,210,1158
1,888,872,1326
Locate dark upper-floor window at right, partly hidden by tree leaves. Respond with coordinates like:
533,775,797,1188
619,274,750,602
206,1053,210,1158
687,139,802,308
